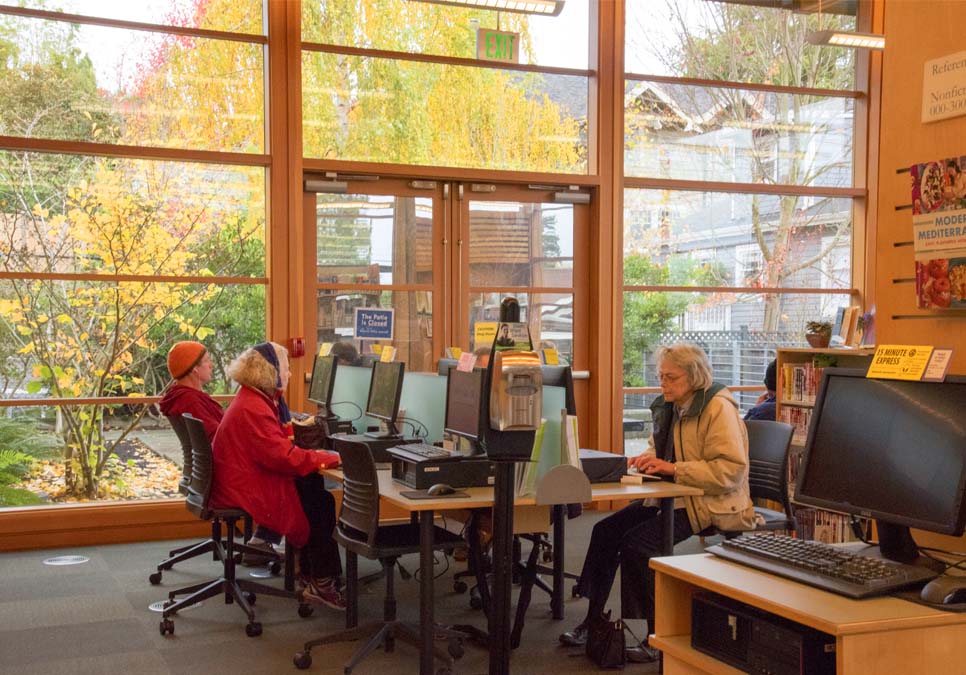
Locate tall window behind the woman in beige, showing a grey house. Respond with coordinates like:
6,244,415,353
623,0,864,454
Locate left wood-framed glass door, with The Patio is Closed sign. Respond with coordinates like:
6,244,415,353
304,176,445,371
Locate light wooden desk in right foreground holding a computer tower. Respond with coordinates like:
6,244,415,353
650,554,966,675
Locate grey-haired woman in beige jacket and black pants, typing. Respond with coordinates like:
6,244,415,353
560,343,755,662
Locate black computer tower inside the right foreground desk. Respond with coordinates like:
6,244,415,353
691,592,835,675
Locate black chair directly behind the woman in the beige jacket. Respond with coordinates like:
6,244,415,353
745,420,798,532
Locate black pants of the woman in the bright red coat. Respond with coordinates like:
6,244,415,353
295,472,342,579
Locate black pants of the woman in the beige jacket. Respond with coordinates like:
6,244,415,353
578,502,693,630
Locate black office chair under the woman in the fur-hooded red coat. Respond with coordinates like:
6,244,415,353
160,414,312,637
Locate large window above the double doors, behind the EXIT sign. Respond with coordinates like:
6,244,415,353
302,0,595,174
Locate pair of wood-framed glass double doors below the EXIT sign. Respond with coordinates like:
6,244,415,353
304,175,590,414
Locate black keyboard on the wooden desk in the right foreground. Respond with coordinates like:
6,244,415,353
706,534,937,598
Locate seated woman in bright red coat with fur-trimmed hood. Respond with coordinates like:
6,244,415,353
210,342,345,610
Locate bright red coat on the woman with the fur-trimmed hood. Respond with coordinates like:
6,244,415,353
210,386,339,546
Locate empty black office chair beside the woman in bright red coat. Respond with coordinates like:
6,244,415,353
292,441,463,674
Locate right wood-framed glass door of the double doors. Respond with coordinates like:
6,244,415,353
448,183,590,400
